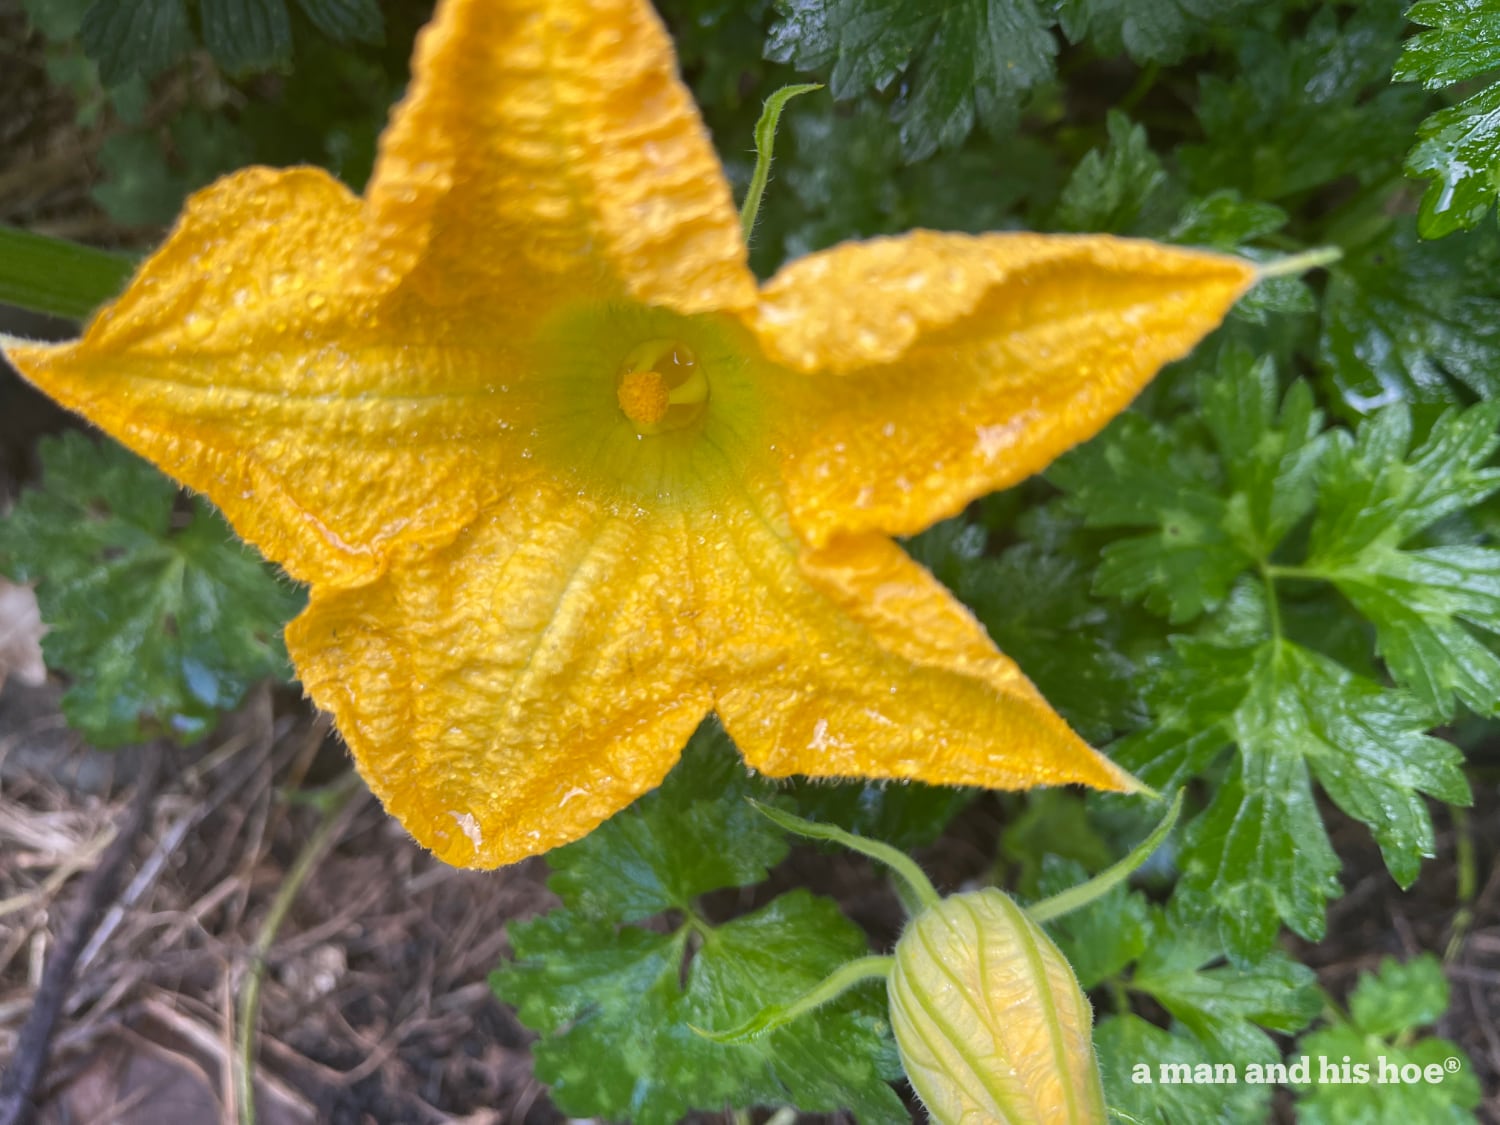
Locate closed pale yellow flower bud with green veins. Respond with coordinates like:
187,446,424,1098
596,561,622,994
890,888,1106,1125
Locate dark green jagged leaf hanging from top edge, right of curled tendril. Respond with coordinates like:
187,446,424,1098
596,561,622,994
765,0,1058,161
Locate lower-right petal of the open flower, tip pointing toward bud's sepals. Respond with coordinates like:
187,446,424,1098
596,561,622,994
699,483,1139,789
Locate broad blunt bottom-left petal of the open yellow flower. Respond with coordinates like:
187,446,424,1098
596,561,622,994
287,483,710,867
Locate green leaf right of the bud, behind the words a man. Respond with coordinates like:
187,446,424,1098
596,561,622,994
1094,1016,1272,1125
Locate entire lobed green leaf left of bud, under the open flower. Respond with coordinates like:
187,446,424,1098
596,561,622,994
492,732,908,1125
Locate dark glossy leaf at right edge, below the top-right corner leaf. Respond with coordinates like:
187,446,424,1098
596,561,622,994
1319,219,1500,414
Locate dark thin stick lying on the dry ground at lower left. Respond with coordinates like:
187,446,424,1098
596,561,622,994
0,743,162,1125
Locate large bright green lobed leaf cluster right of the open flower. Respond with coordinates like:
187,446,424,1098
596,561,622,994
1050,357,1500,963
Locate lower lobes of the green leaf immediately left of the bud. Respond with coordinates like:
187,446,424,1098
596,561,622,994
491,890,909,1125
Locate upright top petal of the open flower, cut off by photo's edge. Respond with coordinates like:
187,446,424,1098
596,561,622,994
358,0,755,324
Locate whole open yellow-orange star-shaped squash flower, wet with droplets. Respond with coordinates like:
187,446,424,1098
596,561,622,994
8,0,1254,867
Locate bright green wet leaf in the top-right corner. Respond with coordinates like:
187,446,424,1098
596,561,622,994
1394,0,1500,239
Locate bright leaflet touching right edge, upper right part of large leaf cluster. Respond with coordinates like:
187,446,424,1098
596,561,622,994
1305,402,1500,719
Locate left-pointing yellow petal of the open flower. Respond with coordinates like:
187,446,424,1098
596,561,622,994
8,168,527,585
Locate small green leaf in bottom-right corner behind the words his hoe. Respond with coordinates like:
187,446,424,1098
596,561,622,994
1298,954,1481,1125
